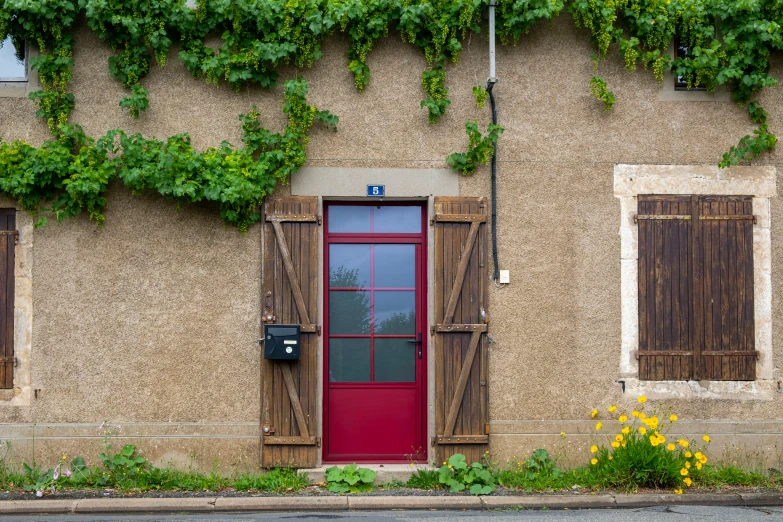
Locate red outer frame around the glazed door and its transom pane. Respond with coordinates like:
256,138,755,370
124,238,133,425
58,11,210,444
319,198,431,464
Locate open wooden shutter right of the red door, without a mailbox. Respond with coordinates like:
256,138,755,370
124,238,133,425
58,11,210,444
433,197,489,462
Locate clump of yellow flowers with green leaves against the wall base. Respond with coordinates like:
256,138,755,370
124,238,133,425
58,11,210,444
590,396,710,494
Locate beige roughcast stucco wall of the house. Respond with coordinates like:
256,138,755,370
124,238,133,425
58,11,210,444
0,16,783,468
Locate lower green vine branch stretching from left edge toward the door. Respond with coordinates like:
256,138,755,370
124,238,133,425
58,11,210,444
0,80,337,232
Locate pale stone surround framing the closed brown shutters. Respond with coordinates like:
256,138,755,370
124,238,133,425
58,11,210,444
614,164,777,400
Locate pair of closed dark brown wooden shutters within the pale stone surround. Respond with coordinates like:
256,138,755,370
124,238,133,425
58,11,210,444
636,196,757,381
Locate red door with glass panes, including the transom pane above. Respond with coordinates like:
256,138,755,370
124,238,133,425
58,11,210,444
323,203,427,462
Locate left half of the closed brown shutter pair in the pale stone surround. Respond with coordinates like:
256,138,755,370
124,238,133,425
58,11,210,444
638,196,693,381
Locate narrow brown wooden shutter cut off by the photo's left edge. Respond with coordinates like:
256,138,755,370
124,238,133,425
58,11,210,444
0,208,17,389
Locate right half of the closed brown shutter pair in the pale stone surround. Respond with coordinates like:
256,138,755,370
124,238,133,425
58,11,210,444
696,196,756,381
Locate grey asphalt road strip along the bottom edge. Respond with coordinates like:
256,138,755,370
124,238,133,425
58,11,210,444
0,506,783,522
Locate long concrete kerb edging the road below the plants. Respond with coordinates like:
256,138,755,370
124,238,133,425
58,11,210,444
0,492,783,516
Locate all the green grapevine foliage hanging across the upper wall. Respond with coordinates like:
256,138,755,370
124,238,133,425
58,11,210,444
0,0,783,228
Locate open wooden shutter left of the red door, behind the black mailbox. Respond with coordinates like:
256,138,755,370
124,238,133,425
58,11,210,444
261,196,320,468
